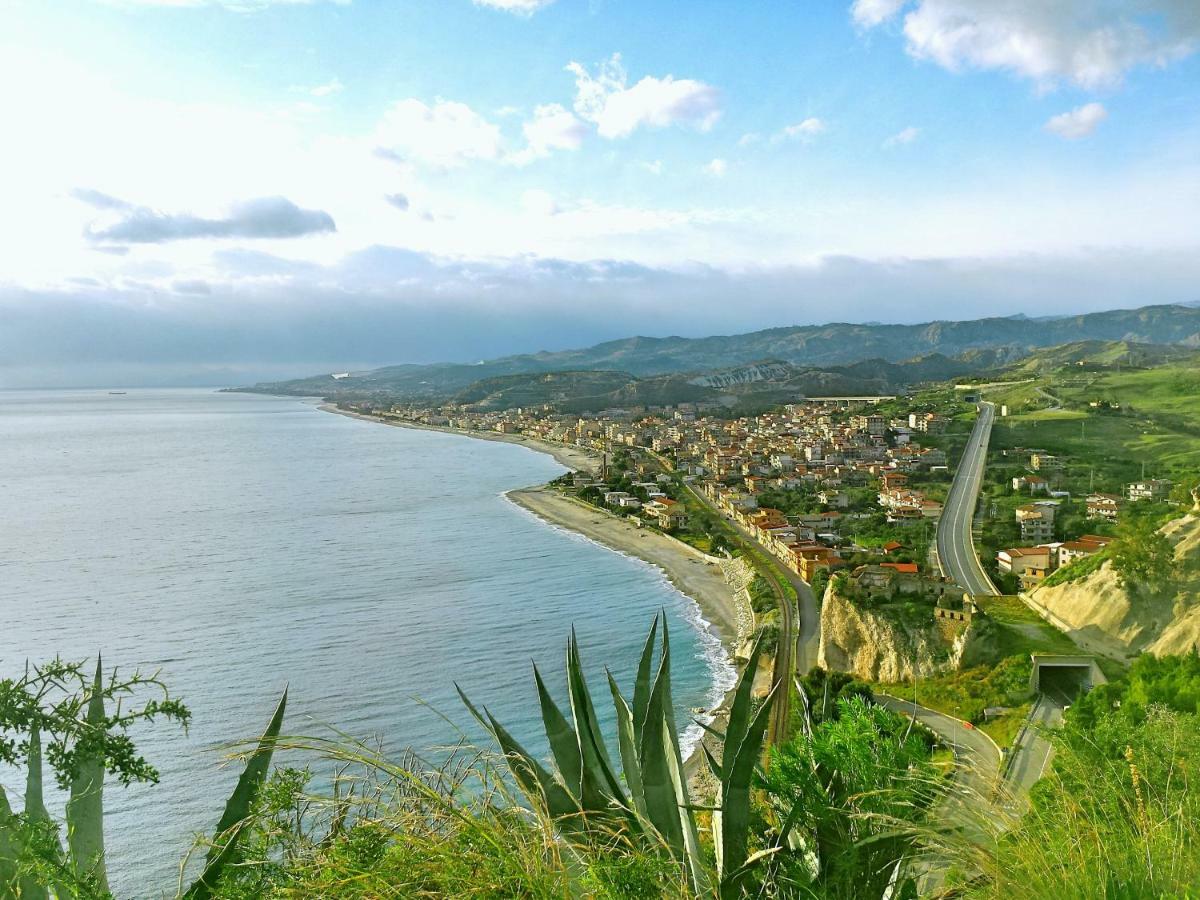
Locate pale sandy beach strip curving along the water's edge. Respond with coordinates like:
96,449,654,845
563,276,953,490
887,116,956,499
318,403,740,770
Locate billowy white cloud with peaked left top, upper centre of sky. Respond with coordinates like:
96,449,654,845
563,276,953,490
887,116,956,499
566,53,721,138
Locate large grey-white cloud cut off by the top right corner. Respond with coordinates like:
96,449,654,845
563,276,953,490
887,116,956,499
851,0,1200,88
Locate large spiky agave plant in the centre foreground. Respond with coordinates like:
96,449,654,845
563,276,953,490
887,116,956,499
458,614,778,898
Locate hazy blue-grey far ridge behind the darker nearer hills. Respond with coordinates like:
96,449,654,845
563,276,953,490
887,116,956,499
241,306,1200,400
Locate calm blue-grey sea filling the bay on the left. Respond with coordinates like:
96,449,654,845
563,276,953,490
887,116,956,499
0,390,730,896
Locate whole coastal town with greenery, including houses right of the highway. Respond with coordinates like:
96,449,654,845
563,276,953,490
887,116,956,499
343,395,1171,607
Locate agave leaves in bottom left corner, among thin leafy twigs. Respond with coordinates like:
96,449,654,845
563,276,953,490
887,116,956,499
0,660,288,900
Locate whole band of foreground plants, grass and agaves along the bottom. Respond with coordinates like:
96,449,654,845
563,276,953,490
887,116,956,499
9,638,1200,900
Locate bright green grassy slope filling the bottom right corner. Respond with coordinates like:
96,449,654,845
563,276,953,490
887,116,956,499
966,655,1200,900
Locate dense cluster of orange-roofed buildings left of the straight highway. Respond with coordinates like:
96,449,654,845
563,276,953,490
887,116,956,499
391,398,947,590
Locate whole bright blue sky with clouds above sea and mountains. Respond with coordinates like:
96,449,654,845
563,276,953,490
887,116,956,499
0,0,1200,388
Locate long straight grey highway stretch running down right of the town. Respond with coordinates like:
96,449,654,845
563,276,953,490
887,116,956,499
937,402,1000,594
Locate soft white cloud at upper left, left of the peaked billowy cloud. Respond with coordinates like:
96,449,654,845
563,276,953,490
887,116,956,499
376,98,500,169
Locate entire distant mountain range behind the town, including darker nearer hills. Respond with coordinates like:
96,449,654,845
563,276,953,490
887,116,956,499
242,306,1200,412
